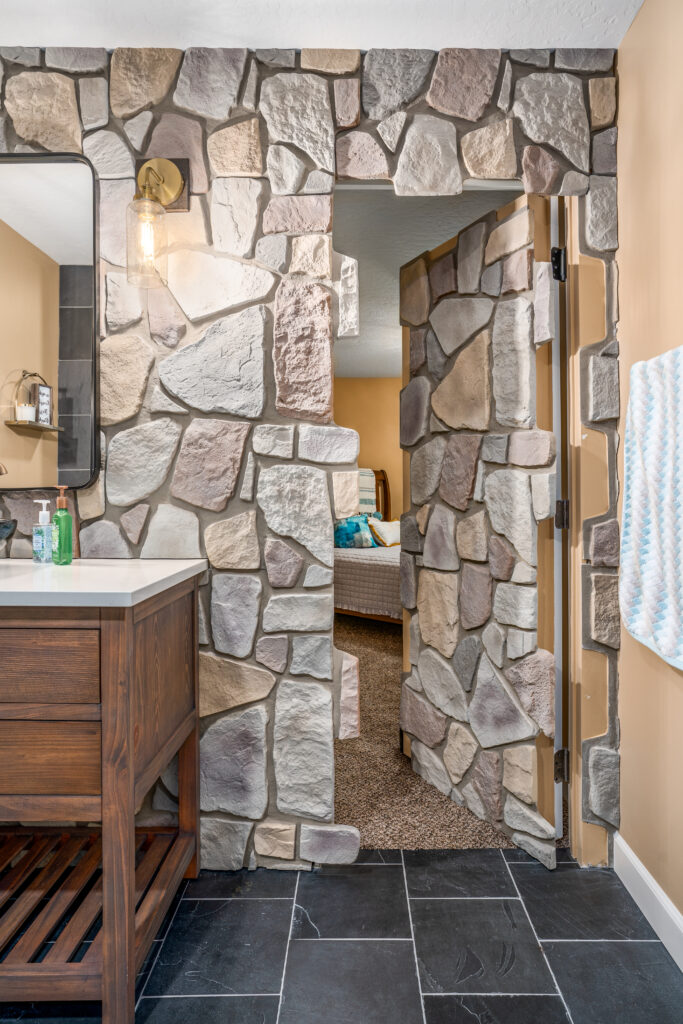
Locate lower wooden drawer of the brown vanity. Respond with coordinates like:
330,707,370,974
0,722,101,797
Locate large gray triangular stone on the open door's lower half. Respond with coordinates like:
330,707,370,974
469,654,538,746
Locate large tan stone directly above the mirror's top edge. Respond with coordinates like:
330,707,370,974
5,71,81,153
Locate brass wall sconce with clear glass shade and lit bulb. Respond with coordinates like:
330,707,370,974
126,157,189,288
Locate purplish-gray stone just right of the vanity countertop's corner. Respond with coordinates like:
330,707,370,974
211,572,263,657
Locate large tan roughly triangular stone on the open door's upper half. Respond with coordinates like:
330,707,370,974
431,331,490,430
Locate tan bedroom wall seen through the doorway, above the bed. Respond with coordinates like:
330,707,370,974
335,377,403,519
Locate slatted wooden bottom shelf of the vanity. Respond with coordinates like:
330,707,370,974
0,828,195,1001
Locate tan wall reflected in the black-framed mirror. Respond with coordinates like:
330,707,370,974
0,220,59,487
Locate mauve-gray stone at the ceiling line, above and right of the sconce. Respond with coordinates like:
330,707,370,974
173,46,247,121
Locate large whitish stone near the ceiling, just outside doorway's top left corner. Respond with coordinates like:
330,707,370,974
260,73,335,171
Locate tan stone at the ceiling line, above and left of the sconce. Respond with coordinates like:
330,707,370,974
110,46,182,118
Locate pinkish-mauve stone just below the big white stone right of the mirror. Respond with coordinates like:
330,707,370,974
171,419,250,512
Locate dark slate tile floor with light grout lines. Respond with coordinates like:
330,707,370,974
0,850,683,1024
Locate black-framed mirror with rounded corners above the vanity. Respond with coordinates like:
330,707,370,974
0,154,98,490
